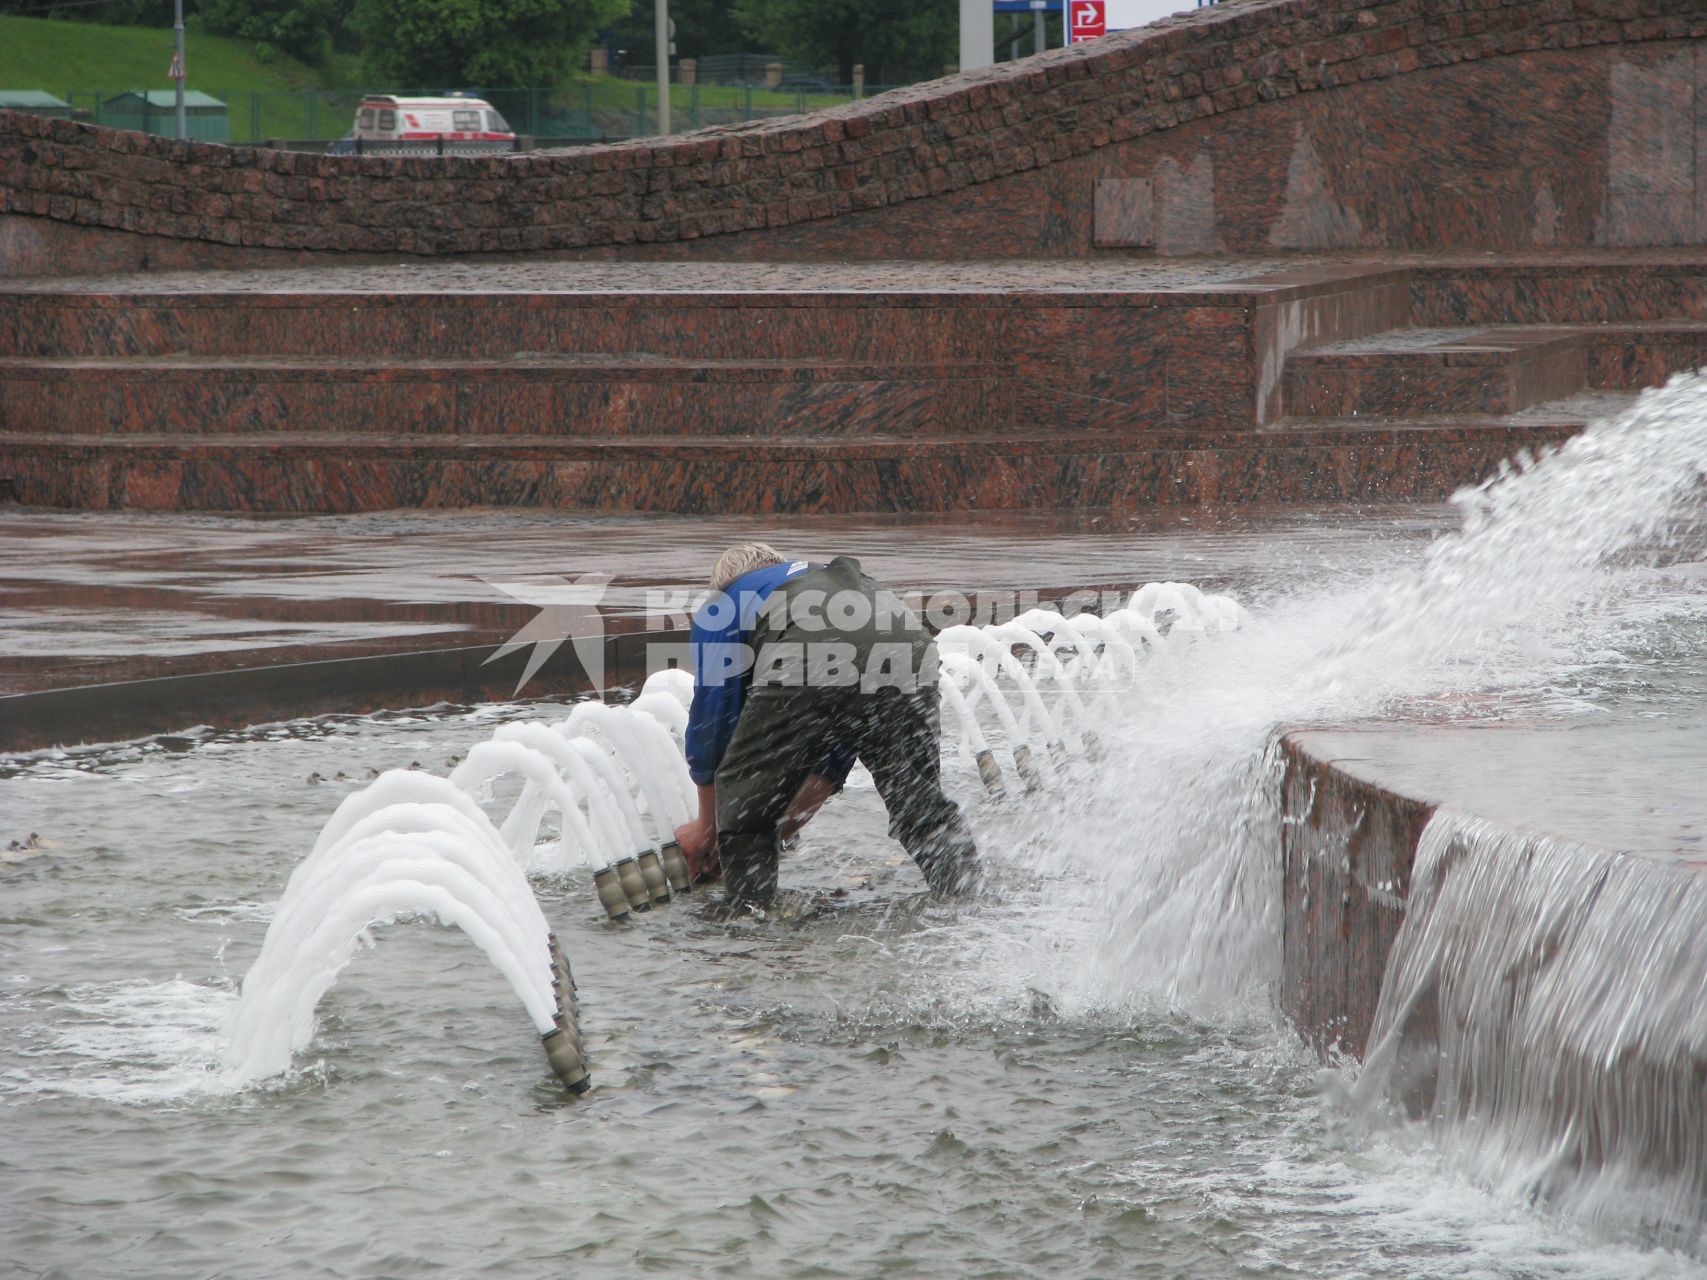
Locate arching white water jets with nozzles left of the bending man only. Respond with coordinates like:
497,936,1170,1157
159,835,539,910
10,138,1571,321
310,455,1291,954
215,672,713,1092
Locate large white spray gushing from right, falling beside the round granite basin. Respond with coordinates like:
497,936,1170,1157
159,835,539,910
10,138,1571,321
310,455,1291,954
990,375,1707,1019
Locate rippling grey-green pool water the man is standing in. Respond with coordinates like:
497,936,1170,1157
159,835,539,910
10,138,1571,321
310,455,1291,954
0,707,1704,1278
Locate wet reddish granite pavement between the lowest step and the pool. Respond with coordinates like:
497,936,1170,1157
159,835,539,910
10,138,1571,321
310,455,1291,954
0,505,1451,695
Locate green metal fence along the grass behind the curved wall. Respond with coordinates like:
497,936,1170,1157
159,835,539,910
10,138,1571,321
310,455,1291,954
53,77,908,154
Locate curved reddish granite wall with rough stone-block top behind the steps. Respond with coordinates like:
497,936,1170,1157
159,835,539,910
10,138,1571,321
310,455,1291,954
0,0,1707,273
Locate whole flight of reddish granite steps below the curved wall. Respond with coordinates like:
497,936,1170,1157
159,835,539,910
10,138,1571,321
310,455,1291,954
0,259,1707,514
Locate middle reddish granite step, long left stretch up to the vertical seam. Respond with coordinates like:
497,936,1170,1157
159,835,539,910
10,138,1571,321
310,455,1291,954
0,353,1010,437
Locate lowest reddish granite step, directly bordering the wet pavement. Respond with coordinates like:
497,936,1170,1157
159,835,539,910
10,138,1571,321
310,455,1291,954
0,423,1576,514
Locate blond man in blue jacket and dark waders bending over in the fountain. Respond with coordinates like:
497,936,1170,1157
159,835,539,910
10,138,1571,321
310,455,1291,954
676,543,978,906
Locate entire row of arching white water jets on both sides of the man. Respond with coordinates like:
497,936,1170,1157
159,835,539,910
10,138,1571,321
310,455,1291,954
216,584,1241,1092
